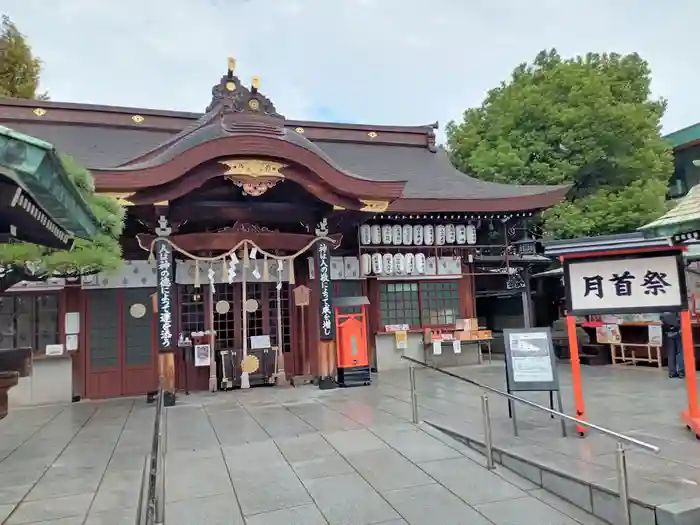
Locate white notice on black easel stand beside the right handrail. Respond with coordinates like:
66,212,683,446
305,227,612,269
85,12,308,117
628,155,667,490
509,332,554,383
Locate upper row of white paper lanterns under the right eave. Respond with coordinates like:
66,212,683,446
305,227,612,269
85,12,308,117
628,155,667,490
360,224,476,246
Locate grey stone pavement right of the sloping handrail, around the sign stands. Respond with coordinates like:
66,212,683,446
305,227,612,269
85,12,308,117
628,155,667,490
382,362,700,506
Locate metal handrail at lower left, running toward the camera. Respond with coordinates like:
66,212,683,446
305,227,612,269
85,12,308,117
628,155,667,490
136,388,165,525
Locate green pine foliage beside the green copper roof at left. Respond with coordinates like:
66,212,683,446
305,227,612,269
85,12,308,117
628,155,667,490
0,155,125,292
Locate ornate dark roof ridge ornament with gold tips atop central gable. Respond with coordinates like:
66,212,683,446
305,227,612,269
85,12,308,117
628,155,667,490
206,57,284,119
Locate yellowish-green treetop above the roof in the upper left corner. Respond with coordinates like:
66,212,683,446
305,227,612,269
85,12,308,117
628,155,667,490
0,15,48,100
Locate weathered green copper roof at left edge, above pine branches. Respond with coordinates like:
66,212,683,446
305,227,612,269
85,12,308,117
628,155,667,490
0,126,99,239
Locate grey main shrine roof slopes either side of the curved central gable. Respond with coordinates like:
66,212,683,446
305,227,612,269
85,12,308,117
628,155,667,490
0,99,569,213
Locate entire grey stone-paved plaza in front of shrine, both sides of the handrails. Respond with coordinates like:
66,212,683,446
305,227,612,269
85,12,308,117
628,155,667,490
0,363,700,525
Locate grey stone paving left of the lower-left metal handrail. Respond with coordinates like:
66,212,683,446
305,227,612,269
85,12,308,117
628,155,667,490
0,399,152,525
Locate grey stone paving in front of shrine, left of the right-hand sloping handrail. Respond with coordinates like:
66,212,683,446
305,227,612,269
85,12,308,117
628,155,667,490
0,373,601,525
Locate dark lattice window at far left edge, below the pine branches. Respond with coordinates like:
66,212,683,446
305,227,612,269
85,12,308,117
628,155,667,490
0,294,60,354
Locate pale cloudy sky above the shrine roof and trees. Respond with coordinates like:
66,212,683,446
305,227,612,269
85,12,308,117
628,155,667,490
0,0,700,141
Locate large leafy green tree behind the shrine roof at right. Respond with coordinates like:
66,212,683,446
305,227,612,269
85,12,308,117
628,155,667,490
447,49,673,238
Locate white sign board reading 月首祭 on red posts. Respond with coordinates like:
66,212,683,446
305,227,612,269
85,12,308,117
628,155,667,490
564,253,687,315
